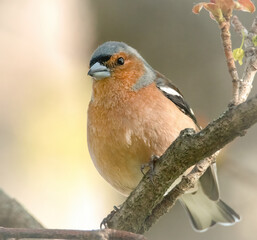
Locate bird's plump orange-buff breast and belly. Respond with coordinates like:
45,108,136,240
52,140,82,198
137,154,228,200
88,80,195,195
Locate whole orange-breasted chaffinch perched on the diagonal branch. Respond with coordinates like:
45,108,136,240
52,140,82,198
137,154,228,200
87,41,240,232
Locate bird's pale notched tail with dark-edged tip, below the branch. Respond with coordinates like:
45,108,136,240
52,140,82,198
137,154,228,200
180,187,240,232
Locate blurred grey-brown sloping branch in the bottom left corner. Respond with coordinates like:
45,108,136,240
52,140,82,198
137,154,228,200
0,189,43,228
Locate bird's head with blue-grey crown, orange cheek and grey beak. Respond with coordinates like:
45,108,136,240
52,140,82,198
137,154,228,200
88,41,155,90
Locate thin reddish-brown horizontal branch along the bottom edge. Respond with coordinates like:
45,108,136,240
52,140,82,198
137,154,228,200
0,227,146,240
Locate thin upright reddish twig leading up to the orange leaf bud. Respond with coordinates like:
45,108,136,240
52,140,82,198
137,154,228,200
219,20,240,105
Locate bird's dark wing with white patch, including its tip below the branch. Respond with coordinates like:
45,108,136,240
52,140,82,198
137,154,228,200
155,71,219,200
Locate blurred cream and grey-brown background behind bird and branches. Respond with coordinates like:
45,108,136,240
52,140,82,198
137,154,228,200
0,0,257,240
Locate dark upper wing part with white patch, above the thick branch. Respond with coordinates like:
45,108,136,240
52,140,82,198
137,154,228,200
155,71,200,129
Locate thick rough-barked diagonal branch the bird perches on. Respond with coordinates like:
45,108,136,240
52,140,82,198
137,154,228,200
104,96,257,233
